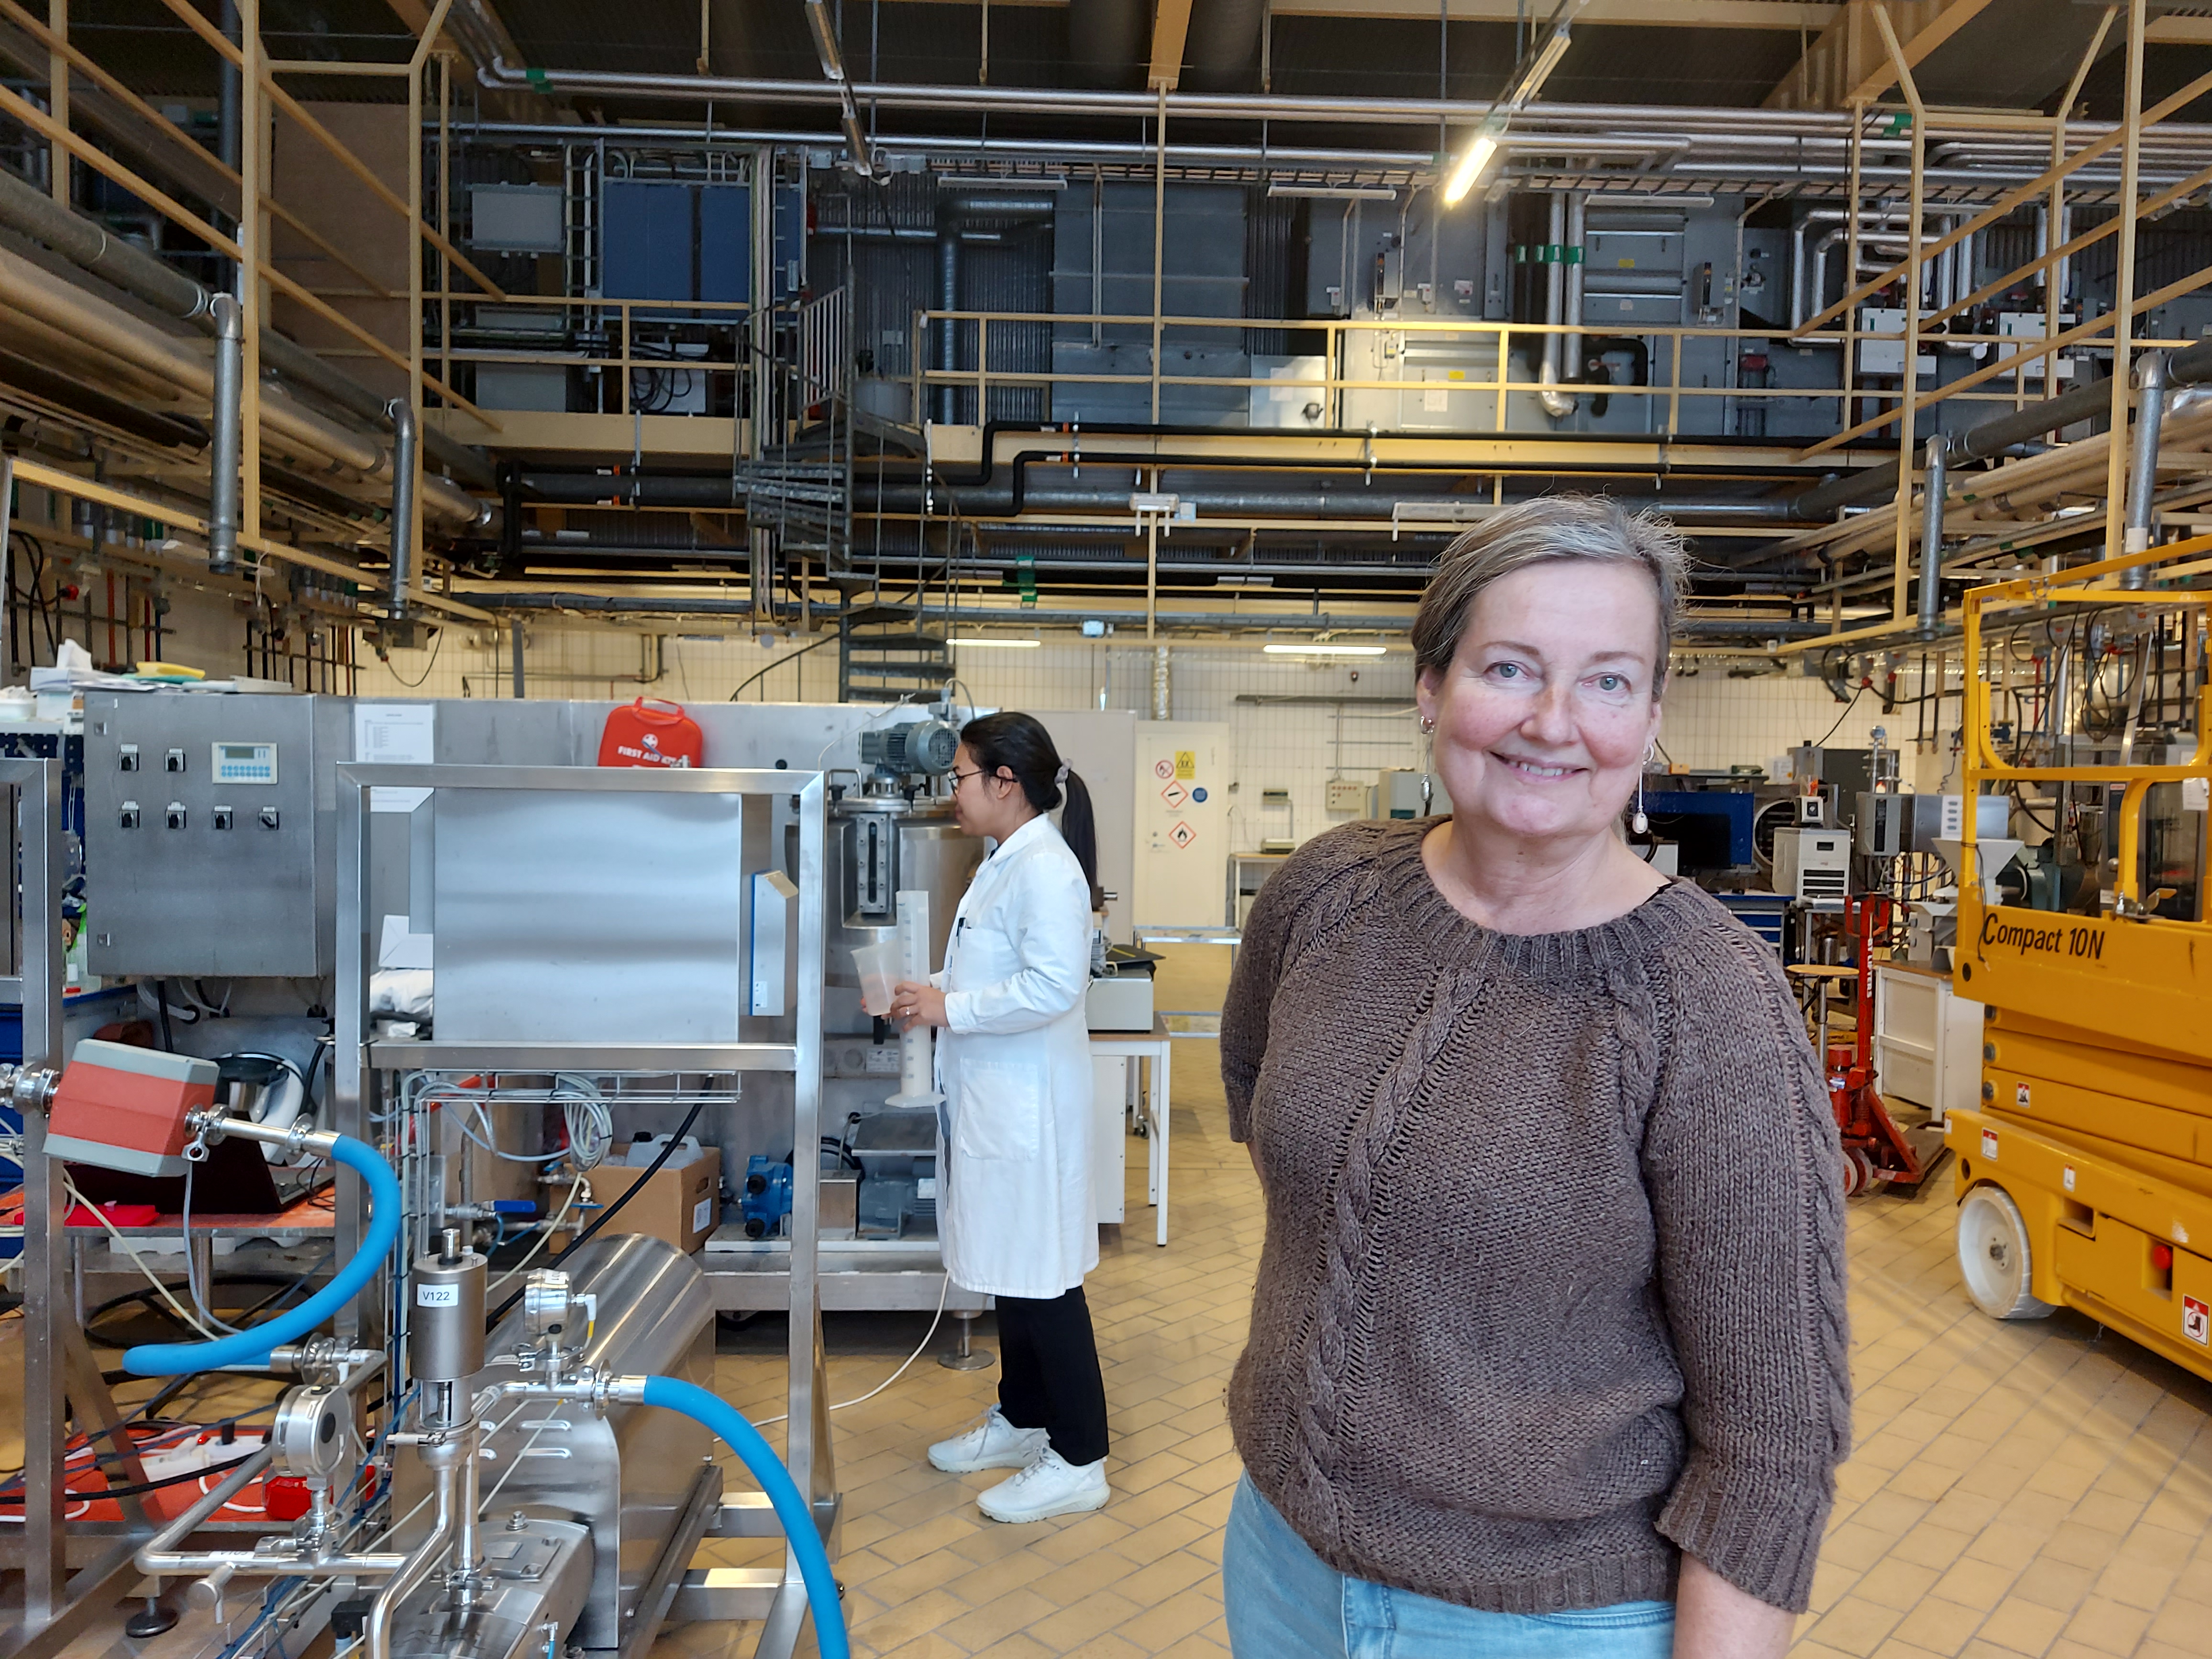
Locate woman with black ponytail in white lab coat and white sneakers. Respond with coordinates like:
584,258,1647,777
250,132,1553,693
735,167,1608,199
891,715,1106,1522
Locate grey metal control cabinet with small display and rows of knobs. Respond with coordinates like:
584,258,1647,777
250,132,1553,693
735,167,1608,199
84,692,352,978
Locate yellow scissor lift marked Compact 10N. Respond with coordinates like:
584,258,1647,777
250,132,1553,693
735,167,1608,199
1947,538,2212,1376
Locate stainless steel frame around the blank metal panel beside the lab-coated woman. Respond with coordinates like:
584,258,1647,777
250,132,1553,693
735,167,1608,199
336,763,841,1659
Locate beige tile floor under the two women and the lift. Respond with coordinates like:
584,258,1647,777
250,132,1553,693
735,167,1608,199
22,947,2212,1659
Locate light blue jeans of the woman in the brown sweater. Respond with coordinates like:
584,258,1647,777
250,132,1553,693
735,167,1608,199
1221,1475,1674,1659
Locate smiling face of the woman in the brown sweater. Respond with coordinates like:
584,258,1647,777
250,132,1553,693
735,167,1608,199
1416,560,1659,841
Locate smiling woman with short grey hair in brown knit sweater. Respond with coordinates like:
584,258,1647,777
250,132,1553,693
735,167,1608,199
1221,498,1849,1659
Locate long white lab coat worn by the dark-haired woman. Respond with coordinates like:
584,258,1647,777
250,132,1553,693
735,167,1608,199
936,814,1099,1301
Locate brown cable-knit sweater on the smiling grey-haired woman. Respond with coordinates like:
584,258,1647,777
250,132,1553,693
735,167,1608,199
1221,821,1851,1613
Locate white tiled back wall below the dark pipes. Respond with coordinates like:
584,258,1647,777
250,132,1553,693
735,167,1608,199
361,626,1958,850
